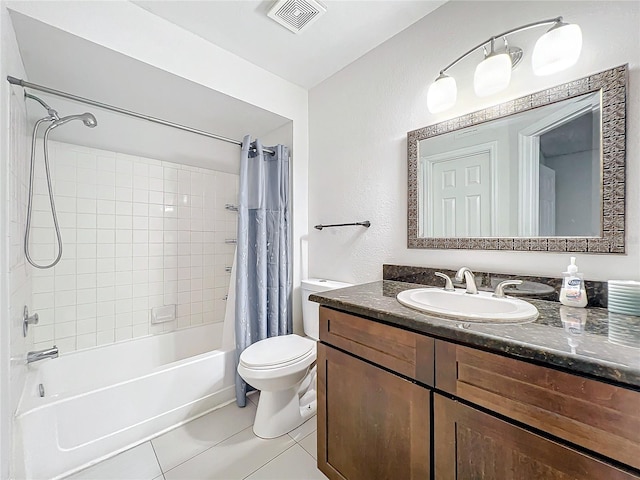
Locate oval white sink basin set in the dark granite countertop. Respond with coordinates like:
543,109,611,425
396,288,538,323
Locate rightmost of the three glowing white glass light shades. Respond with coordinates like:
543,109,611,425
532,23,582,76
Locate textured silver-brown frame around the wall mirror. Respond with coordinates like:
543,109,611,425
407,64,628,253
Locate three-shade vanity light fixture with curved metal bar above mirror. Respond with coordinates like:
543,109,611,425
427,17,582,113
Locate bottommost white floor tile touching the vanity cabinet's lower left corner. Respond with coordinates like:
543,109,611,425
245,445,327,480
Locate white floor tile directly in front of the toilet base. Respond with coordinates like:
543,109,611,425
164,427,295,480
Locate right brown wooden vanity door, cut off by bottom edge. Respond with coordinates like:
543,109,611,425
433,394,640,480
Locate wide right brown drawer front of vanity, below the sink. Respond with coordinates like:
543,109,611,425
435,340,640,469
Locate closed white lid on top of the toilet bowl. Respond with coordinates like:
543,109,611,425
240,334,316,368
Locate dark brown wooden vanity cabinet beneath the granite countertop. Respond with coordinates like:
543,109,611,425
318,307,640,480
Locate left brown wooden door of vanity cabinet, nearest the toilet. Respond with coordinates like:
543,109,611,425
318,344,431,480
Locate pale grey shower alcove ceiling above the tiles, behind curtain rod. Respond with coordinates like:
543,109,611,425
9,11,291,173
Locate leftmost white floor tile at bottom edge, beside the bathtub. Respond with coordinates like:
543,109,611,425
67,442,162,480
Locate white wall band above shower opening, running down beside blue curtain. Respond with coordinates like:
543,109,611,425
7,1,309,318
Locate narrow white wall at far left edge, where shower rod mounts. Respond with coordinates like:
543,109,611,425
0,5,33,478
